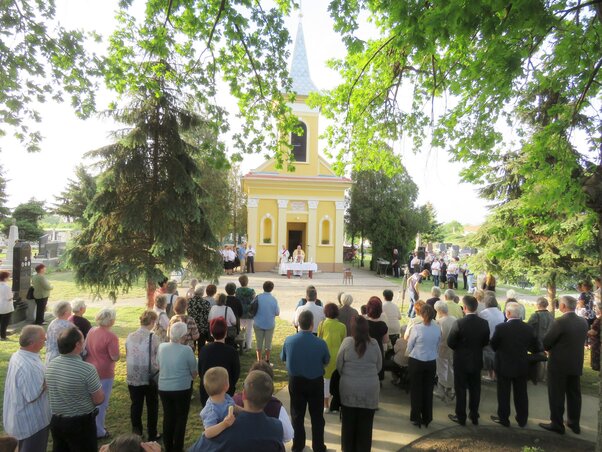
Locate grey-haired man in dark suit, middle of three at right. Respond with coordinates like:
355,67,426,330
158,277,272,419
491,303,539,427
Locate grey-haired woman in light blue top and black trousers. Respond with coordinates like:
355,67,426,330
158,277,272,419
157,322,198,452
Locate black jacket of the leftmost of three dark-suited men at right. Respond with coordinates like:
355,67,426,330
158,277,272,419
447,314,489,373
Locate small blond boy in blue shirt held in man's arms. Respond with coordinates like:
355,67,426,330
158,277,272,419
201,367,239,438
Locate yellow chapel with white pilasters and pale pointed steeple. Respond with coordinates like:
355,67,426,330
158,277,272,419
242,23,351,272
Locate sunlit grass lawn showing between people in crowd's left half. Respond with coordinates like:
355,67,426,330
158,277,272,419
0,308,295,450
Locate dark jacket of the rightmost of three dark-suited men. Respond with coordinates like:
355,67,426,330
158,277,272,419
543,312,588,375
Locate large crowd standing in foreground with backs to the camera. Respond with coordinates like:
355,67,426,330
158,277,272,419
0,267,602,452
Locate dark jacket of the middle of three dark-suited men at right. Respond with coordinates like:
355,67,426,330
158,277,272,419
491,319,540,378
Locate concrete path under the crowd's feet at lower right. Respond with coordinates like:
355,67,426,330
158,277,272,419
276,372,598,452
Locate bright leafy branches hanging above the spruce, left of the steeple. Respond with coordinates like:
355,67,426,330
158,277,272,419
105,0,297,165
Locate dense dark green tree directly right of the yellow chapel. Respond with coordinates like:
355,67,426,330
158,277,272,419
345,162,424,260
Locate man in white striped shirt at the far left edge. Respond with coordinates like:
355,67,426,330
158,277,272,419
2,325,50,452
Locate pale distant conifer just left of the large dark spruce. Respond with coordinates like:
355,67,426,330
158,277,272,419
54,165,96,227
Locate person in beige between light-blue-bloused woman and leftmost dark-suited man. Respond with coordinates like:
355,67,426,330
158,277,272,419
435,300,457,402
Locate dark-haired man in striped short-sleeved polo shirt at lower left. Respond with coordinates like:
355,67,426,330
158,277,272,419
46,326,105,452
